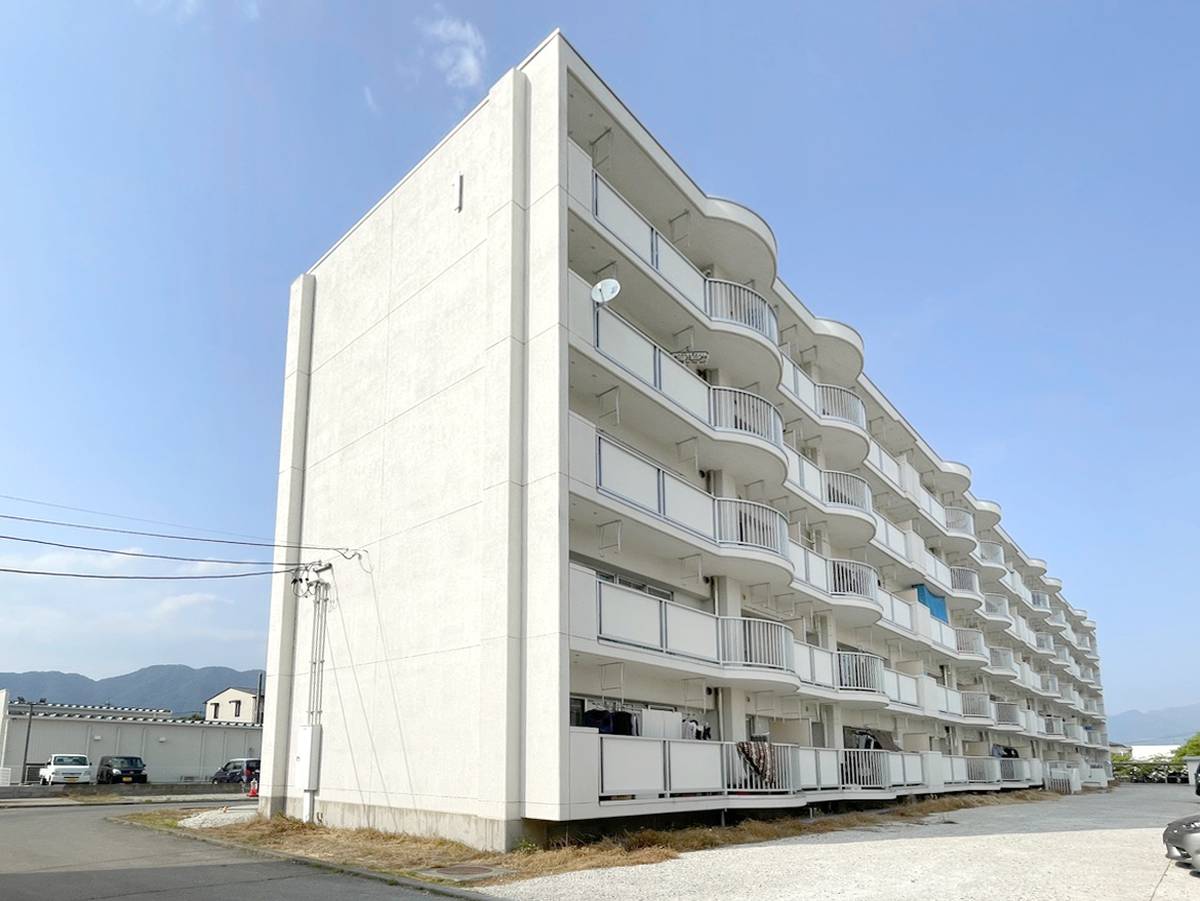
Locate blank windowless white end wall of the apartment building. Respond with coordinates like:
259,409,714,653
263,35,569,847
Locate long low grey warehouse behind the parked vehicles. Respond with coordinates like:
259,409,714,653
0,689,263,785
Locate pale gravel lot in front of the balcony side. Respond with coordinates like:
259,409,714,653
487,785,1200,901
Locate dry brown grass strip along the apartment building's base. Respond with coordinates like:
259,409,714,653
124,789,1058,885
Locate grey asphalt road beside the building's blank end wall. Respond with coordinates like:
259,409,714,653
0,804,433,901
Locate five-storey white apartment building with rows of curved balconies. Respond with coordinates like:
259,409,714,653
262,32,1108,847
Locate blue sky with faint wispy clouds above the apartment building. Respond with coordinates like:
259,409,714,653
0,0,1200,711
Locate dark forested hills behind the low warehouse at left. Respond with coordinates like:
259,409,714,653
0,663,263,714
